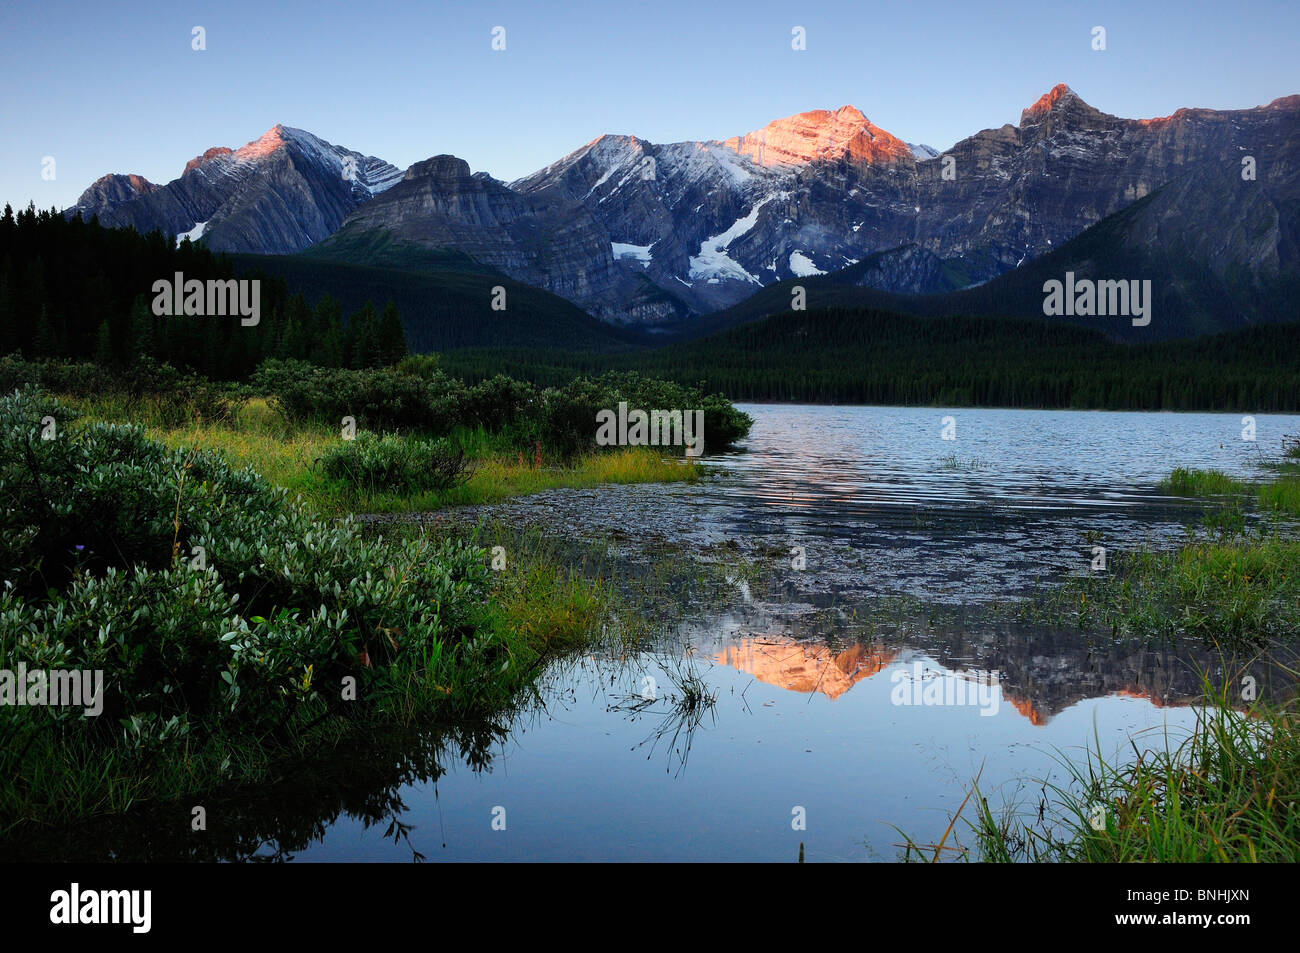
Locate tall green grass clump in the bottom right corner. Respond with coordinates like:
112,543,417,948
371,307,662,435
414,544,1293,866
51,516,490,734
901,681,1300,863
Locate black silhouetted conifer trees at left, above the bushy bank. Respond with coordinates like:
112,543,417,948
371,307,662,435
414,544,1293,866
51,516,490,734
0,205,407,380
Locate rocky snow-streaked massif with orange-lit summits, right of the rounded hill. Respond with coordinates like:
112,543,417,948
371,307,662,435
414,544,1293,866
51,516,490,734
514,86,1300,312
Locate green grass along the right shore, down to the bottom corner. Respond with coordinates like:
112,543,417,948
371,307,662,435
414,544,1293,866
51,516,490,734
900,462,1300,863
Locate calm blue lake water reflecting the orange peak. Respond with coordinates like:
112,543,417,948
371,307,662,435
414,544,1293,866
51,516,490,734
55,406,1300,861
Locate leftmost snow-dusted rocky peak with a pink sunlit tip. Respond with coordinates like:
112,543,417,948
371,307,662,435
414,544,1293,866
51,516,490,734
69,126,402,254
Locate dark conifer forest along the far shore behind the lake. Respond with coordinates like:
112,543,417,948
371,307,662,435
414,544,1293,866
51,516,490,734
443,309,1300,411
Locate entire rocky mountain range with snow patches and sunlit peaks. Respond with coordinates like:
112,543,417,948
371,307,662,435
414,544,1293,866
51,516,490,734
68,85,1300,337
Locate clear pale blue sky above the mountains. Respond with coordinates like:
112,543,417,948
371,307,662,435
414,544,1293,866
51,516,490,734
0,0,1300,208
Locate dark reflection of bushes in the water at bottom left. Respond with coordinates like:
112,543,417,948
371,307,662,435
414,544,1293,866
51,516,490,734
0,724,507,863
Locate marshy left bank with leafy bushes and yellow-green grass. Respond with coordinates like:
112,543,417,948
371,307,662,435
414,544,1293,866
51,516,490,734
0,361,744,839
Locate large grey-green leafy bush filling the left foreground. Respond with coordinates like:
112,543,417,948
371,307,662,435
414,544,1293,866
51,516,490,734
0,390,488,748
